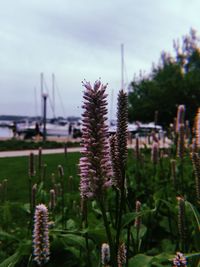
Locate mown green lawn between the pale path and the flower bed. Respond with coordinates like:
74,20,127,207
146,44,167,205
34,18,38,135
0,153,80,203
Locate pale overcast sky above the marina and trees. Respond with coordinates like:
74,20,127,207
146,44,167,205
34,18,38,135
0,0,200,116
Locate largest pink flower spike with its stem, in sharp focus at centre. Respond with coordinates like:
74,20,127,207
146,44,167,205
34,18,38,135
79,80,116,266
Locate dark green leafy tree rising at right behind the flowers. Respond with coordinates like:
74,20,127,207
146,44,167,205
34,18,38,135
129,30,200,125
